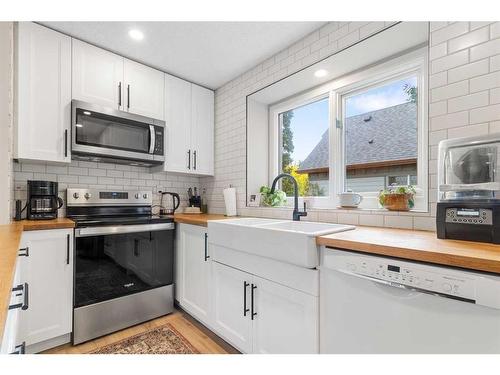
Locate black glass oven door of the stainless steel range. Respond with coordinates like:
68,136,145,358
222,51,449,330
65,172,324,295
74,223,174,308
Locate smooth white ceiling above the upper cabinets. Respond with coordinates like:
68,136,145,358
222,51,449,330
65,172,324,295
42,22,324,89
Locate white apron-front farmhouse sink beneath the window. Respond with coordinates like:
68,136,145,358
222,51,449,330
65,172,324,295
208,218,354,268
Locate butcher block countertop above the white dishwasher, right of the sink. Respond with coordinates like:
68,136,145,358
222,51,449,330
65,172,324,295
316,226,500,273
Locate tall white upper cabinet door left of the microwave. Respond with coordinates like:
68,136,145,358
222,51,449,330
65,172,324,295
14,22,71,163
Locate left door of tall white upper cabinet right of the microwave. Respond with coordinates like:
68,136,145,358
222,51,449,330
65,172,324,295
165,74,192,173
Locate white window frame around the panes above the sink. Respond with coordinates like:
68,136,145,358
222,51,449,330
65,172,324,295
269,47,429,211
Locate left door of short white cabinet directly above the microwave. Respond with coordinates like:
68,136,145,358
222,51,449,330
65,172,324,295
72,39,125,110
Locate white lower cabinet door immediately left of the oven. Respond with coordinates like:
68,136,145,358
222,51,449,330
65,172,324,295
19,229,73,351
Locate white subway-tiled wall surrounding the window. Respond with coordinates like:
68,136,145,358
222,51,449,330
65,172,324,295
202,22,500,230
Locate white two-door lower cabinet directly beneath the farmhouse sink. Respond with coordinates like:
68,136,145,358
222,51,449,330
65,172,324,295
212,262,319,354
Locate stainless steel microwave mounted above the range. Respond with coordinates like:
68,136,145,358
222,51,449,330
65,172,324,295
71,100,165,166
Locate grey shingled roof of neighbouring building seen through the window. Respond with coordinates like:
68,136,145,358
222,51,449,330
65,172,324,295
297,102,418,173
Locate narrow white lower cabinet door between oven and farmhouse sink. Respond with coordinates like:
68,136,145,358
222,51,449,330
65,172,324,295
175,224,212,325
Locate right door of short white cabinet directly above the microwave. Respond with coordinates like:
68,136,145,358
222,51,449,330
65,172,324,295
124,59,165,120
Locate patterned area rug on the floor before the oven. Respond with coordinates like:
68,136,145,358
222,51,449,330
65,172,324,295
89,323,199,354
